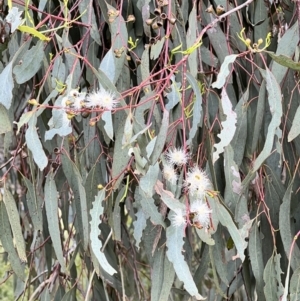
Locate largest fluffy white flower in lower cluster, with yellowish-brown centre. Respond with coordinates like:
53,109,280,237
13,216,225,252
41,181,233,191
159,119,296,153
184,166,211,199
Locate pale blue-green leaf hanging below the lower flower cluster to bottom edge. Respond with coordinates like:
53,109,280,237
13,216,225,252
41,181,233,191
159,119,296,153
166,221,205,300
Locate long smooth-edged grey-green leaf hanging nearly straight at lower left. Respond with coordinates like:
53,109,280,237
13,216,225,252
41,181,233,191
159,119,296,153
45,170,66,272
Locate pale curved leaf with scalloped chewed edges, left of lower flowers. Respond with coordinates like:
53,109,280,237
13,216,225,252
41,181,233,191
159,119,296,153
90,189,117,275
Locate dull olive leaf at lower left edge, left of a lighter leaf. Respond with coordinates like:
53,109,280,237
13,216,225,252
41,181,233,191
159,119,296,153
0,195,25,281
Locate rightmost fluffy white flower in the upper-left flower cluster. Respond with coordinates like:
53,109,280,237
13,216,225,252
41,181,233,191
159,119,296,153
85,88,118,111
